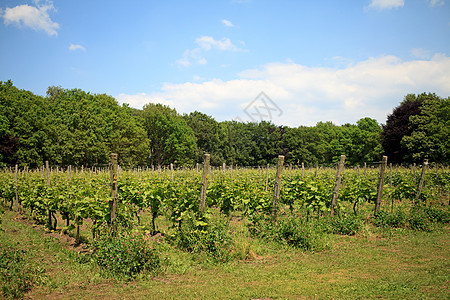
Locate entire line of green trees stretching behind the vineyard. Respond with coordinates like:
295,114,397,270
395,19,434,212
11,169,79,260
0,80,450,167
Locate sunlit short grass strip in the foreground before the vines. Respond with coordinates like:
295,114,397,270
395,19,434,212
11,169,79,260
0,212,450,299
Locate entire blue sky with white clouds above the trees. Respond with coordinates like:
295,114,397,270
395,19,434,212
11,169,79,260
0,0,450,127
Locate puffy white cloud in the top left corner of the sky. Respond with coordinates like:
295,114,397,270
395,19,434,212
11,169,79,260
3,1,59,35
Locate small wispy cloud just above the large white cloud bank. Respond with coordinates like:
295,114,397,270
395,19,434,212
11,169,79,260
176,36,246,67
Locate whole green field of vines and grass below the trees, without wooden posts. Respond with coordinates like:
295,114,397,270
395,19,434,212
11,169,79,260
0,167,450,299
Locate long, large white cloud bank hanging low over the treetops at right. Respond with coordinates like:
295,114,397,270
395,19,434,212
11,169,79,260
118,54,450,127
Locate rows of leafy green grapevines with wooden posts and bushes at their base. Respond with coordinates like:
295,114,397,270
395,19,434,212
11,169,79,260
0,156,450,298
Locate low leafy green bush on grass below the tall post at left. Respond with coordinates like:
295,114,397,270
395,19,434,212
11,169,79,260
91,233,161,279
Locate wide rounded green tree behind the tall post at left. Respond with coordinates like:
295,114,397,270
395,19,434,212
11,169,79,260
45,87,148,166
